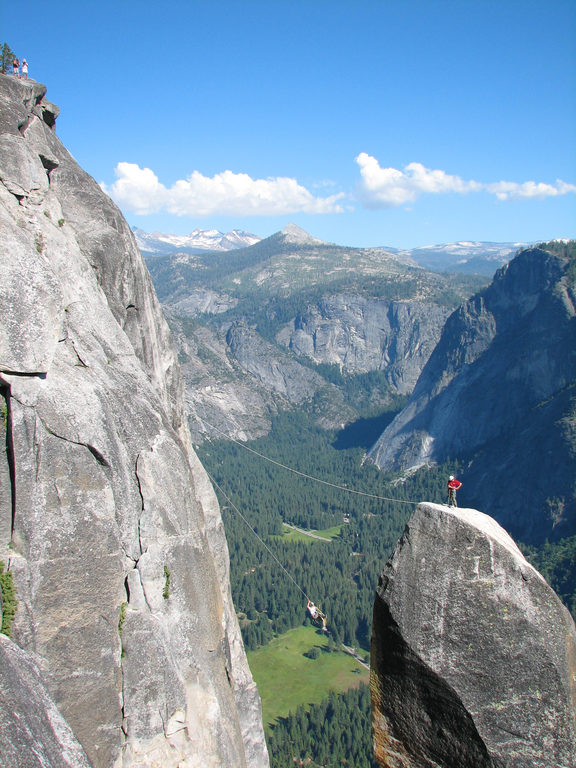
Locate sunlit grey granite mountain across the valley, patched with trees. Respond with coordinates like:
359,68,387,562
148,225,485,442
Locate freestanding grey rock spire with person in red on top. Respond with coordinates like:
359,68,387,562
371,504,576,768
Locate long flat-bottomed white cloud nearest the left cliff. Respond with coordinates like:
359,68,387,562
102,163,344,217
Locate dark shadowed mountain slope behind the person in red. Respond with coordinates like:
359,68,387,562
369,248,576,543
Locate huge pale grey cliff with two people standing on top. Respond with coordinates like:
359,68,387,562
0,76,268,768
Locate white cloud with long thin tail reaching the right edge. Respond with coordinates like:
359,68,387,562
356,152,576,208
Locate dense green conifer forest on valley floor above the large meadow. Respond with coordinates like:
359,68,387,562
200,413,464,649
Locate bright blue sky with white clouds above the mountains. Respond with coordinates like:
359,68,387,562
0,0,576,248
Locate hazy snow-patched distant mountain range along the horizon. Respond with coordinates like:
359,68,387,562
133,224,530,276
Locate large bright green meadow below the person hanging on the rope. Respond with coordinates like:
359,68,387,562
248,626,369,727
